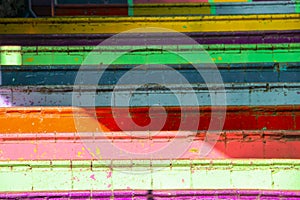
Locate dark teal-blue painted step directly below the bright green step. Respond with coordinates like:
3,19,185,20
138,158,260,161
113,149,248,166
0,62,300,85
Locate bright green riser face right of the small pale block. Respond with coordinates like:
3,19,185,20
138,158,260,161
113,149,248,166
18,51,300,65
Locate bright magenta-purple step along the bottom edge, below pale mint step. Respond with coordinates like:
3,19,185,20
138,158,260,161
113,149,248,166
0,190,300,200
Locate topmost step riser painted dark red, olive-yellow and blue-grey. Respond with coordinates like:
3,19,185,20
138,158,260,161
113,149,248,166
55,2,298,16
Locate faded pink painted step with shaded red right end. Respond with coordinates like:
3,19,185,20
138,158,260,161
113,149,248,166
0,130,300,161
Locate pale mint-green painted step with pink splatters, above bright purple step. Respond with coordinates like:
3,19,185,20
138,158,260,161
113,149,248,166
0,159,300,192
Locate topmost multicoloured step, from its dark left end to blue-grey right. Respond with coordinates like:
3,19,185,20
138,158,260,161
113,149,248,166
32,0,299,16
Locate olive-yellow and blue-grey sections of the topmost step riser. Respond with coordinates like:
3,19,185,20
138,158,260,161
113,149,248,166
129,1,298,16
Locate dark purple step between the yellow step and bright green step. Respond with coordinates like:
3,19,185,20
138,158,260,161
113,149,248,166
0,30,300,46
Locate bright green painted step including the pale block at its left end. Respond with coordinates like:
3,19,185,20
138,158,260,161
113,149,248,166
0,43,300,65
